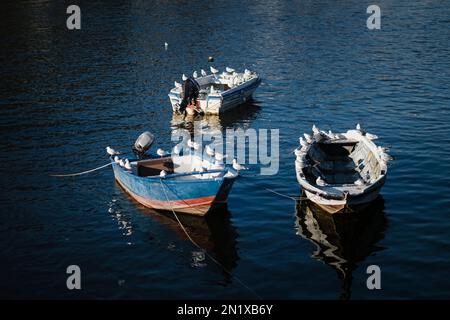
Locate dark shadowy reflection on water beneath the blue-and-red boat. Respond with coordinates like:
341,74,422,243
111,183,239,285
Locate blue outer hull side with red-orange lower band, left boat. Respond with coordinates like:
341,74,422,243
113,164,235,216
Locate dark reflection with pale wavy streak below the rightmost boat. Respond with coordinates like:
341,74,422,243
296,196,387,299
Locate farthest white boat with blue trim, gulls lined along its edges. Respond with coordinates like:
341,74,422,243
169,67,261,114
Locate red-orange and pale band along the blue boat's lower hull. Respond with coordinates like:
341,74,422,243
116,179,218,216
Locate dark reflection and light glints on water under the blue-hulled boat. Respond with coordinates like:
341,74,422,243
108,186,239,284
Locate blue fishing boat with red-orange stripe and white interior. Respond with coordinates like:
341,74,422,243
111,131,238,216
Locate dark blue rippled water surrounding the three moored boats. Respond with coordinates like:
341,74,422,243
0,0,450,299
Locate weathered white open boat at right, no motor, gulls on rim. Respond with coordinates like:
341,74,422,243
294,124,391,213
